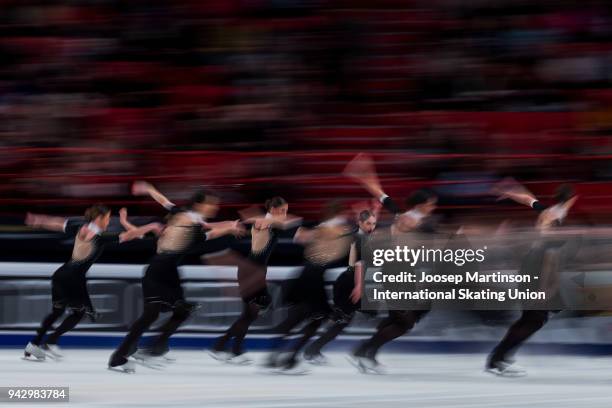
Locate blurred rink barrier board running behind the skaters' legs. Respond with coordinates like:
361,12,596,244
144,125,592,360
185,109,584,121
0,263,612,355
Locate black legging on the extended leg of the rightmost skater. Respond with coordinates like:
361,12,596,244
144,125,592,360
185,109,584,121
489,310,549,366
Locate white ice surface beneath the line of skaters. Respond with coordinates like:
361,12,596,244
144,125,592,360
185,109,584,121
0,349,612,408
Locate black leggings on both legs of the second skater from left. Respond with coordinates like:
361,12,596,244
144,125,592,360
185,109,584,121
110,302,190,366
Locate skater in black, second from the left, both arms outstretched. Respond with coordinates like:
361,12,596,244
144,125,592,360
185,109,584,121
108,182,244,373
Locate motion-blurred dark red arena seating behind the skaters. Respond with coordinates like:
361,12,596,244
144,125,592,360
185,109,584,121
0,0,612,224
